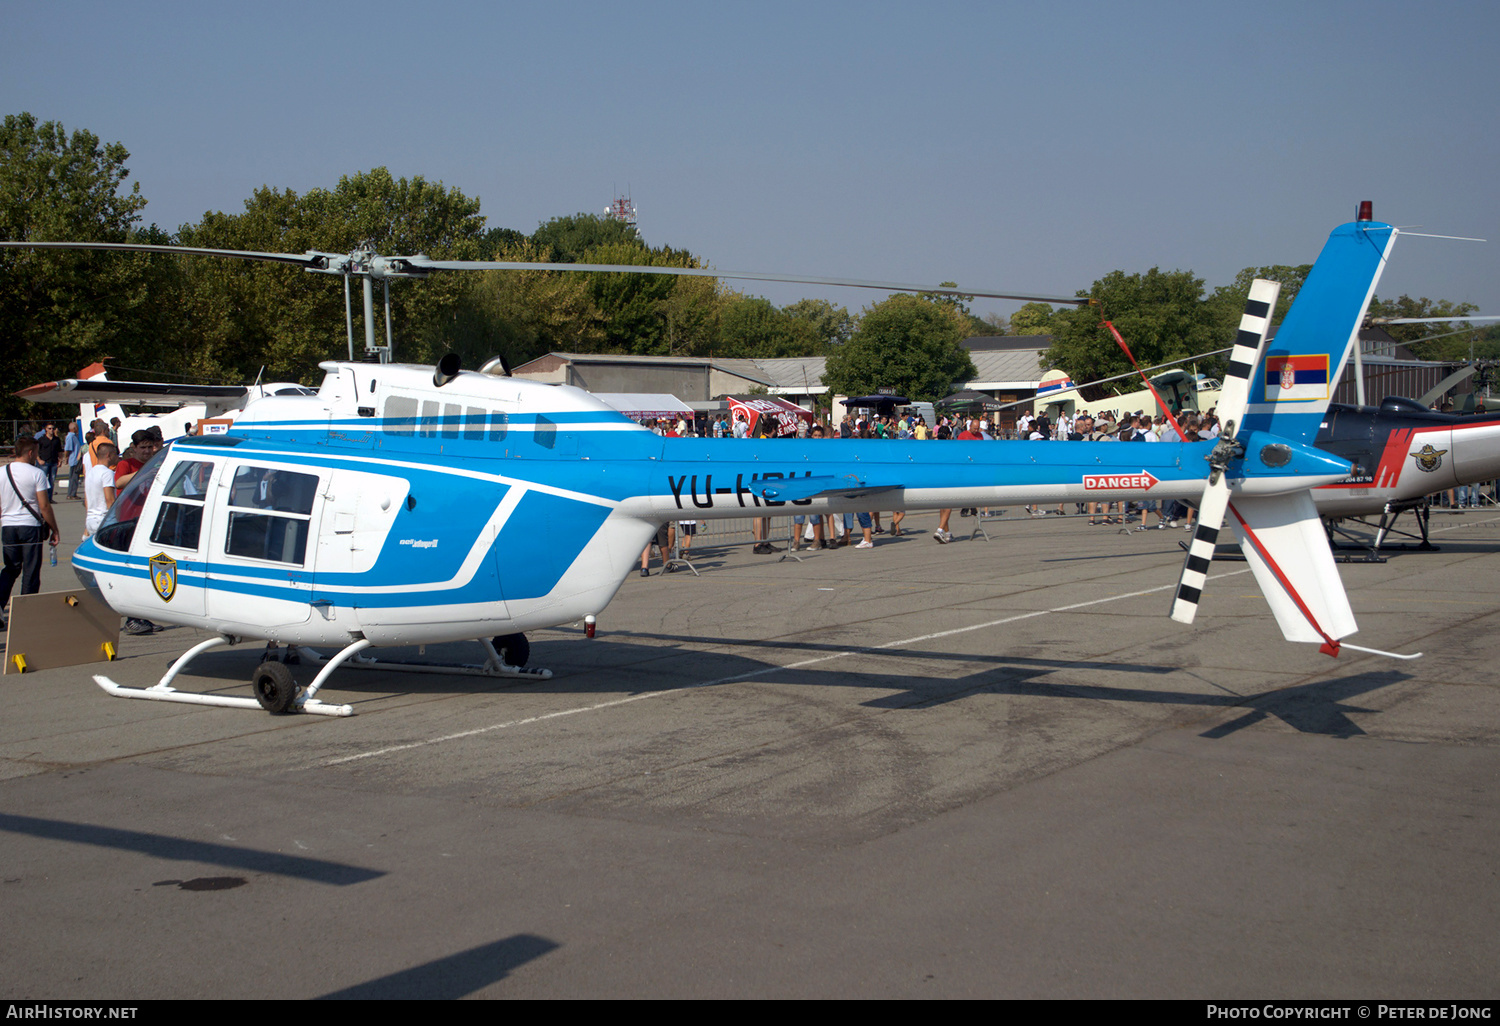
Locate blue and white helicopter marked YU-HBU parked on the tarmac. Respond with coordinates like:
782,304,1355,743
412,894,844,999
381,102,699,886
0,215,1398,716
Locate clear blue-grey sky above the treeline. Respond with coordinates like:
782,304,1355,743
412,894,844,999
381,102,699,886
0,0,1500,321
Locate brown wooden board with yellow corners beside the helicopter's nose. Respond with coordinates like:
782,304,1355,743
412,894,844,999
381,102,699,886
3,588,120,674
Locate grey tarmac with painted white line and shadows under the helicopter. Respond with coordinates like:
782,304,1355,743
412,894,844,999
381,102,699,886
0,501,1500,999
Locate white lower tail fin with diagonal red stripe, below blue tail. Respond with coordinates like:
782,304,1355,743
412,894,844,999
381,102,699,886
1229,492,1359,653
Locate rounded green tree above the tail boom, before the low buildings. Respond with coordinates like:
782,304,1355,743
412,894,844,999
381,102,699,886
824,293,975,402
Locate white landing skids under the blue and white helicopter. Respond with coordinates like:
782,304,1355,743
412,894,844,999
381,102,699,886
95,635,552,716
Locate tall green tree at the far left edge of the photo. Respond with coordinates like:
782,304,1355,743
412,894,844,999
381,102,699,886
0,114,170,417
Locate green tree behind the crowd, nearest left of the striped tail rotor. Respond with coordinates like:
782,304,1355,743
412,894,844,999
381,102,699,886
1044,267,1232,402
